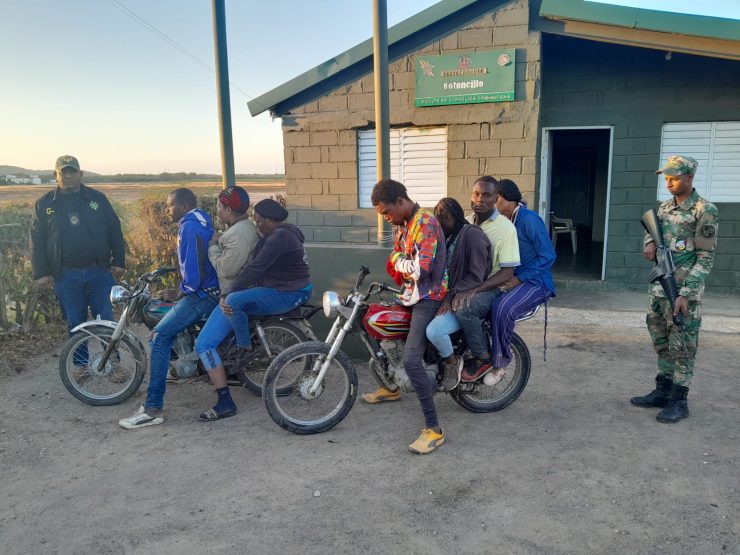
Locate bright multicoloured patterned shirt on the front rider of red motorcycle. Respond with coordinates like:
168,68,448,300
387,207,447,306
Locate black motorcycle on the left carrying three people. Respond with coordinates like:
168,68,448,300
59,267,321,406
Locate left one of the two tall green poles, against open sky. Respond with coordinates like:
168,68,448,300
213,0,236,189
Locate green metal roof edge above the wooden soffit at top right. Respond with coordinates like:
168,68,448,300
540,0,740,41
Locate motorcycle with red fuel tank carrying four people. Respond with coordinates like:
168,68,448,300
263,266,539,434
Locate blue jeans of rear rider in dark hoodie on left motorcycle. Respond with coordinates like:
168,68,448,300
195,285,312,372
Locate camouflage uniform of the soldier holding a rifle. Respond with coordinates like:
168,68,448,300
645,189,719,388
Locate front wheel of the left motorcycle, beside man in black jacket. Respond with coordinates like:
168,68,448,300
59,326,147,407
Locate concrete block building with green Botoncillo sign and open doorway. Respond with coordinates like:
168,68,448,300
249,0,740,294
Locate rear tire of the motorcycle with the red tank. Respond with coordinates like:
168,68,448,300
450,333,532,412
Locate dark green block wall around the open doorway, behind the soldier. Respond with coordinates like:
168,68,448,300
542,36,740,294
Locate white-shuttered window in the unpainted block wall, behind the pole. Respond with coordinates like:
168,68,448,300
357,127,447,208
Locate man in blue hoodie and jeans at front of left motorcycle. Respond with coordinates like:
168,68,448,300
118,188,220,429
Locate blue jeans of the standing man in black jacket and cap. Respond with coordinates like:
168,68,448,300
54,268,115,366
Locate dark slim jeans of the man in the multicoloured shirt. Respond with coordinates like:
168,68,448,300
403,299,442,428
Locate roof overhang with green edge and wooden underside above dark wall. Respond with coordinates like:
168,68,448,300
533,0,740,60
